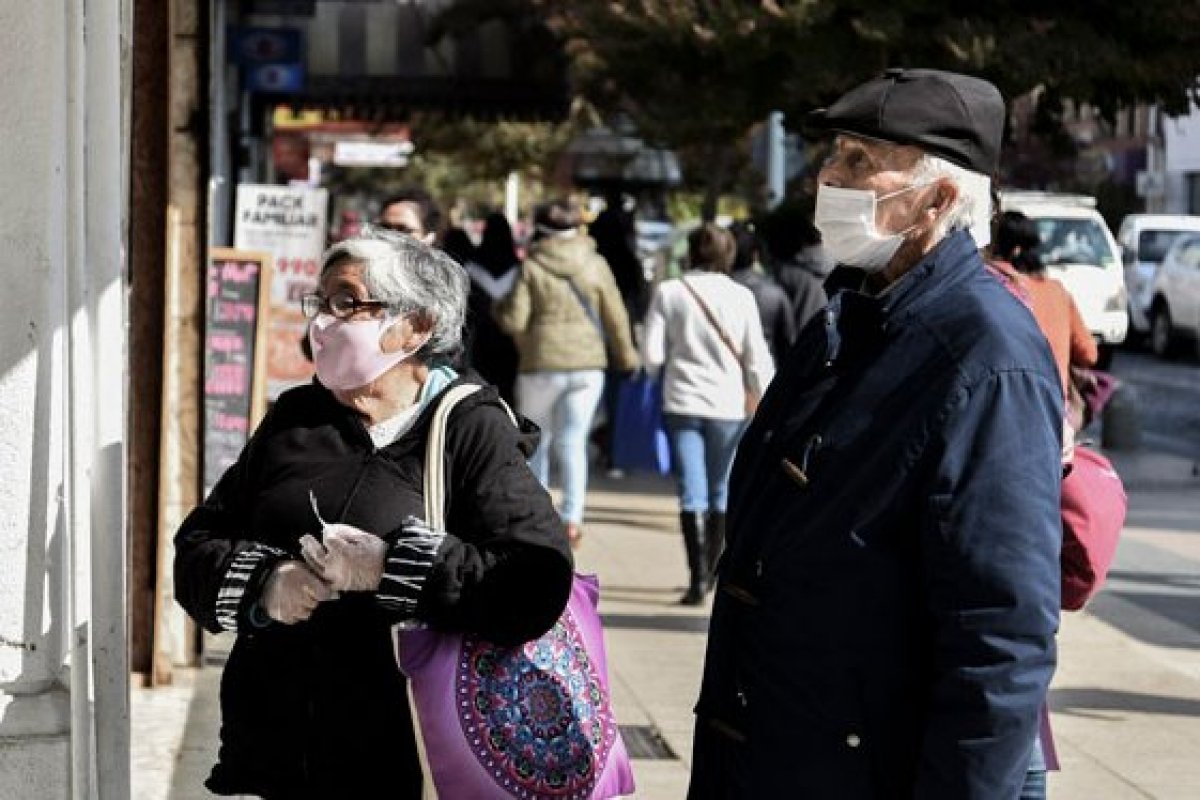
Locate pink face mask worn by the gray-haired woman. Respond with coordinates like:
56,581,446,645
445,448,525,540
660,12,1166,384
308,314,424,391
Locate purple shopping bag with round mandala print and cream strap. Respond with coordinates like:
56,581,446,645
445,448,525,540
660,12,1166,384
392,385,634,800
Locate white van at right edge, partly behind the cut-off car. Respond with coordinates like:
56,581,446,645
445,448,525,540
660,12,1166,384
1117,213,1200,336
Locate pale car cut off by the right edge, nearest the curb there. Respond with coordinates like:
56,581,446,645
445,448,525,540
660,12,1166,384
1150,233,1200,357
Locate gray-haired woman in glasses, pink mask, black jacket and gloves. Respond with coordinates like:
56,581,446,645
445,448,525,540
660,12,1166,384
175,231,572,799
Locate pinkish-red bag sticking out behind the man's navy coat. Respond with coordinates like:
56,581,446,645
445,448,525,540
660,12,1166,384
1062,446,1129,610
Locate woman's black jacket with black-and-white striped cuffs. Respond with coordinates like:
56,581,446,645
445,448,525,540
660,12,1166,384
175,383,572,798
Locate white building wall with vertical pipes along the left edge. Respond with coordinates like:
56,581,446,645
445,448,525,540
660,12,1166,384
0,0,130,800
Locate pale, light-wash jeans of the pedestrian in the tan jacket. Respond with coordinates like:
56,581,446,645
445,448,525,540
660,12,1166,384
516,369,604,524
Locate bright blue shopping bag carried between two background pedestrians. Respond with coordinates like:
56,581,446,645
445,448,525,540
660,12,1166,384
612,372,671,475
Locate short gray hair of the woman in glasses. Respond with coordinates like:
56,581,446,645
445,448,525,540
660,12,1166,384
320,225,470,361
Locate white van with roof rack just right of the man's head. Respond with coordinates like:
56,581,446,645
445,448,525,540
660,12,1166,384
1001,191,1129,367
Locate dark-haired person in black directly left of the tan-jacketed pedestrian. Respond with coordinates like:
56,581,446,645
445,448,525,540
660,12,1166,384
466,212,521,403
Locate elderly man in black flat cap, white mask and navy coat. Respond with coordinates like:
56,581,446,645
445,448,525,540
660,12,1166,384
689,70,1062,800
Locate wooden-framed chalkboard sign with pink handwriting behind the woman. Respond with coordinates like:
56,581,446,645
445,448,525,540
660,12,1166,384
204,247,271,497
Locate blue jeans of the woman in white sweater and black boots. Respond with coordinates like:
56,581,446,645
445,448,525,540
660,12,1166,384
662,414,746,513
